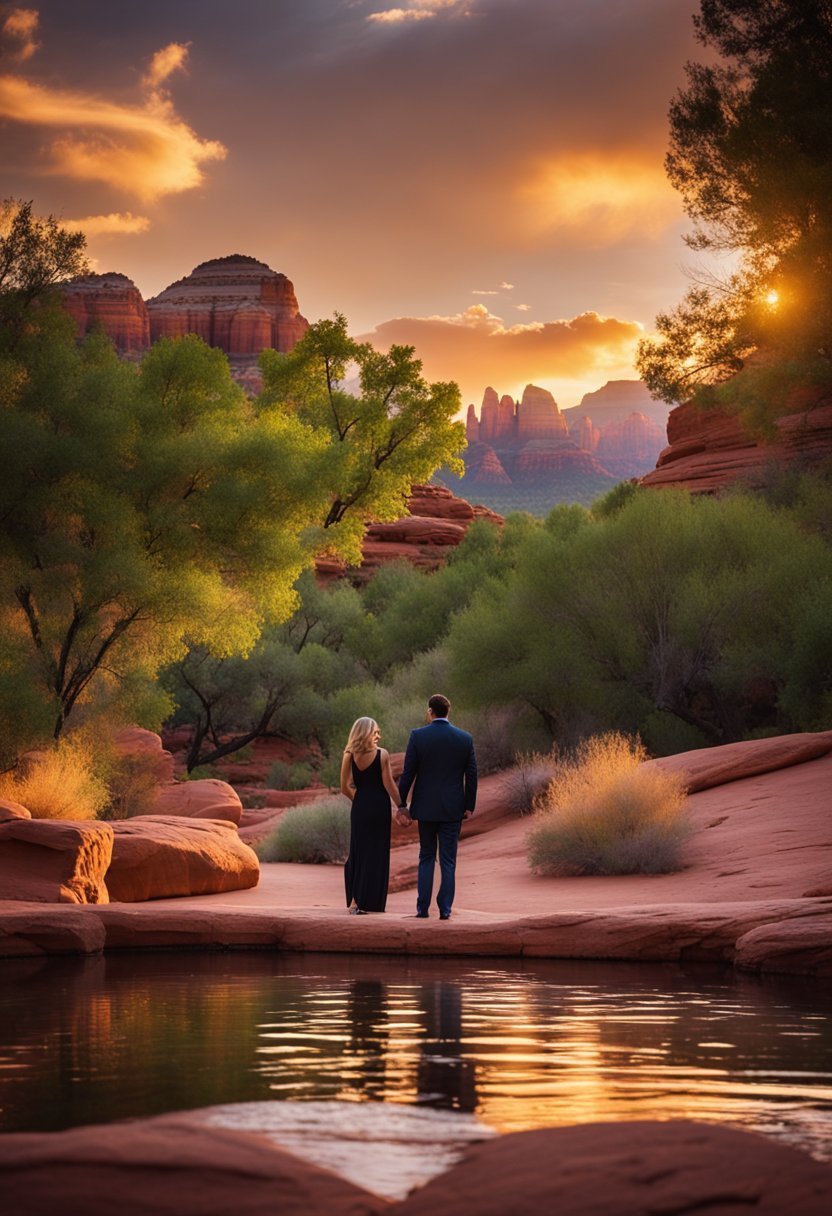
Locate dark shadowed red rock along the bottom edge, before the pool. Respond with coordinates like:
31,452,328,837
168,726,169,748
0,1111,832,1216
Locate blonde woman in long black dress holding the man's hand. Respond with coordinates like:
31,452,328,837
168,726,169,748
341,717,399,914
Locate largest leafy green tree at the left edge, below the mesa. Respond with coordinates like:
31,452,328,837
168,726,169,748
0,310,328,758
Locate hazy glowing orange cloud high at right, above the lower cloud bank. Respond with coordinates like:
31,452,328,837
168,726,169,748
518,151,682,248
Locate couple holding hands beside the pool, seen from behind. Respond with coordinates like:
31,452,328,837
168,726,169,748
341,693,477,921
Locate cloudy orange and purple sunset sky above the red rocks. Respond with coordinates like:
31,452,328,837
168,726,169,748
0,0,701,407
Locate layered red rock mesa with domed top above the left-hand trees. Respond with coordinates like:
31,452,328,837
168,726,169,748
61,254,309,389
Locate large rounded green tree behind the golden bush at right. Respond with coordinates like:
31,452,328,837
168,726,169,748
448,491,832,750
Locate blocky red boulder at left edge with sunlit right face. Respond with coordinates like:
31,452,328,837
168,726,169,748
0,815,113,903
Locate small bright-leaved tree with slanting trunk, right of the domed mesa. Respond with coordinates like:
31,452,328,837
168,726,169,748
259,315,465,564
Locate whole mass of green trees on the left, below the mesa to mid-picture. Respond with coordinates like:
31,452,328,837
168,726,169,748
0,203,465,769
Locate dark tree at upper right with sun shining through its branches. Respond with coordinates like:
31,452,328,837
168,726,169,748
637,0,832,400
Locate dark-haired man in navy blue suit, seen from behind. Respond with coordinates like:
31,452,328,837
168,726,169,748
398,693,477,921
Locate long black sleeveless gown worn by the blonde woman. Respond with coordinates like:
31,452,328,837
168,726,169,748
344,750,390,912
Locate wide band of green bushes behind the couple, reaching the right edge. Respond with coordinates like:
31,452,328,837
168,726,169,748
168,473,832,773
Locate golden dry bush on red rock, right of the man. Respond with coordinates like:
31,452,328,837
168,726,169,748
528,733,688,874
